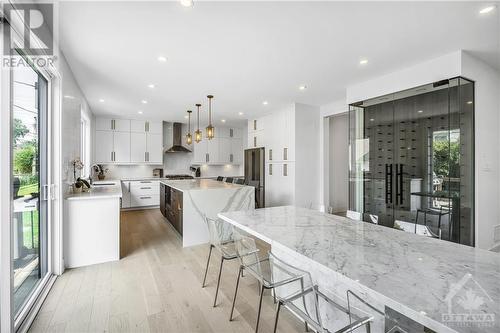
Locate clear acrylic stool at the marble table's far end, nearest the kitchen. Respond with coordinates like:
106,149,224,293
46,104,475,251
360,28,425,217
201,216,238,307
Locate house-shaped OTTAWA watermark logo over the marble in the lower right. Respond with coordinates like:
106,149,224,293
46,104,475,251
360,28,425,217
441,273,496,327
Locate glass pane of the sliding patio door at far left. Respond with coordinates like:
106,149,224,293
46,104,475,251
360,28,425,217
11,61,48,317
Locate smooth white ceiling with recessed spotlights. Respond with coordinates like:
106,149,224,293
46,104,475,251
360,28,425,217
59,1,500,125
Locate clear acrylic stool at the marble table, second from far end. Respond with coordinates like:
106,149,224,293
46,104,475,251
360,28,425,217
229,231,311,333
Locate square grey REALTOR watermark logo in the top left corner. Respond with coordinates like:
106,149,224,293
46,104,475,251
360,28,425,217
2,2,54,67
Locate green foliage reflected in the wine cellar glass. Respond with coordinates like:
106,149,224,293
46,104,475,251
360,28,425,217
432,140,460,178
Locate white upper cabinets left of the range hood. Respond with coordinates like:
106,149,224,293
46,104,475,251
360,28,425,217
95,117,163,164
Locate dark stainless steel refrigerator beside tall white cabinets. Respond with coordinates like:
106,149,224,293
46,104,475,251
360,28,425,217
245,148,266,208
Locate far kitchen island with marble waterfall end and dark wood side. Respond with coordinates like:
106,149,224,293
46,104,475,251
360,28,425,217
160,179,255,247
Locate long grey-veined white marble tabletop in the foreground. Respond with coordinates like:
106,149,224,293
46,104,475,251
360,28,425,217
219,206,500,332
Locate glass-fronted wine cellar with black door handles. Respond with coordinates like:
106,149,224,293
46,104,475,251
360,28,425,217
349,77,474,246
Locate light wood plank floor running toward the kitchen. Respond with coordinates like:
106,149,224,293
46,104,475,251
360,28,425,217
30,209,304,333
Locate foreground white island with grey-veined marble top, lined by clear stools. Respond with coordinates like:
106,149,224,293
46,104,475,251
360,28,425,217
219,206,500,333
